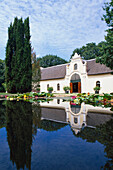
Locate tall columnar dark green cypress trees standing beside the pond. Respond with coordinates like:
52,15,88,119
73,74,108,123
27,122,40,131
5,17,32,93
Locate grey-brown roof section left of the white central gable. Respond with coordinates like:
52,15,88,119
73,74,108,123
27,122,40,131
41,64,67,80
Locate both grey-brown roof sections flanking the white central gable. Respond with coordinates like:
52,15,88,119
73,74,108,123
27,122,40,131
41,59,113,80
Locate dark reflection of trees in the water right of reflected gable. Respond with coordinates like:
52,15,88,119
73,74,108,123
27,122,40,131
74,119,113,169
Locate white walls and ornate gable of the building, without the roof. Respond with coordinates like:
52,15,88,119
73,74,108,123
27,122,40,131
40,53,113,93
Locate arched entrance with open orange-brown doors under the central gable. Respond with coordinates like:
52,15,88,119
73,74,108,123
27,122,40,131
70,74,81,93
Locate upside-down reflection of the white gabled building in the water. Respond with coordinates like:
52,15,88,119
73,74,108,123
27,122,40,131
40,99,113,134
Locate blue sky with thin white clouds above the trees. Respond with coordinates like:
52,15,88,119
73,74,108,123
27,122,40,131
0,0,109,60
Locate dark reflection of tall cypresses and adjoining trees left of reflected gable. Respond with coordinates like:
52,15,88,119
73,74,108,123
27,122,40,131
6,101,67,169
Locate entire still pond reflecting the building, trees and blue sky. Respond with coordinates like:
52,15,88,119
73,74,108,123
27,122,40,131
0,99,113,170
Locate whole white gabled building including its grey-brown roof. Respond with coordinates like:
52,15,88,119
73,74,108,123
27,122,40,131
40,53,113,93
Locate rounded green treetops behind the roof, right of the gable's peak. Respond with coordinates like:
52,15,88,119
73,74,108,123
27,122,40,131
71,41,105,60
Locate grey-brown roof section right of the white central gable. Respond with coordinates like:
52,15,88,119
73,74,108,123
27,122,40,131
86,59,113,75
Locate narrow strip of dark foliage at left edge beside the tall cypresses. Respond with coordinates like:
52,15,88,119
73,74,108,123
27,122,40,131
0,60,5,92
